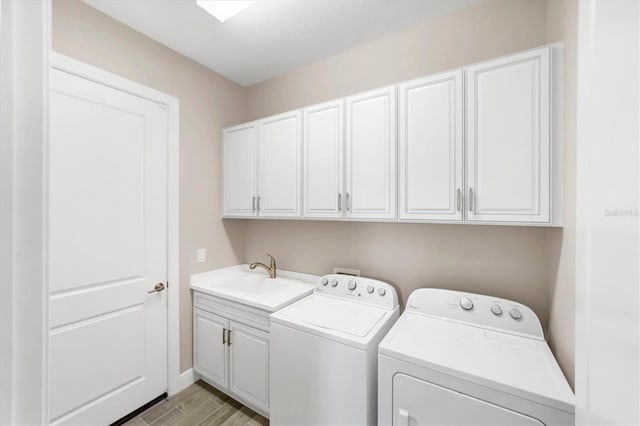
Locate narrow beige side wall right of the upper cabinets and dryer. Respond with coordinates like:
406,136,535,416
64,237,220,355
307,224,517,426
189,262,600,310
547,0,578,390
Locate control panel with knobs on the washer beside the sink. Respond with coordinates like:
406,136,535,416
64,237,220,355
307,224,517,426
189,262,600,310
315,274,398,309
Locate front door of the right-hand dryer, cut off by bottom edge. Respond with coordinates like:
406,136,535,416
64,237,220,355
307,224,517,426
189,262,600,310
393,374,544,426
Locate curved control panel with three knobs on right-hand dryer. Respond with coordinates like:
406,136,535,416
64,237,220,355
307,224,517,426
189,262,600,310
407,288,544,340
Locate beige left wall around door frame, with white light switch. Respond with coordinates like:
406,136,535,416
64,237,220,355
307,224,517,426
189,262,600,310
53,0,246,371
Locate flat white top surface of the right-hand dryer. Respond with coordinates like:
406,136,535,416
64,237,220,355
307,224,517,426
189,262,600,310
379,312,574,413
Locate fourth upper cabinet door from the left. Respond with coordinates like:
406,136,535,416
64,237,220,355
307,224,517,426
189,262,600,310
345,86,396,220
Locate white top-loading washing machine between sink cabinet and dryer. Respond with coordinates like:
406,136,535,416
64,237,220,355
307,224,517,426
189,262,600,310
269,275,399,426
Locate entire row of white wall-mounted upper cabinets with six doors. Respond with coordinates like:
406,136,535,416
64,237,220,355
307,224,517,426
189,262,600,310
223,45,562,226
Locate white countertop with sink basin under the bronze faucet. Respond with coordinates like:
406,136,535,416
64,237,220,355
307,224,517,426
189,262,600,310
190,265,319,312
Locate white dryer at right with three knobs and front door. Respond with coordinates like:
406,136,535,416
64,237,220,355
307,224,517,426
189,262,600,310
378,288,574,426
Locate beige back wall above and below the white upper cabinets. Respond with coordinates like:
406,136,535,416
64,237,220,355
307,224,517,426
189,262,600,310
244,0,575,382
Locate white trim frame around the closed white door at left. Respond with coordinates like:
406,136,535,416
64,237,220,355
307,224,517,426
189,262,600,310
50,51,182,395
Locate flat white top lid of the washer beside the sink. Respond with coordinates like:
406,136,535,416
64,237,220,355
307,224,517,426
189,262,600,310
279,295,388,337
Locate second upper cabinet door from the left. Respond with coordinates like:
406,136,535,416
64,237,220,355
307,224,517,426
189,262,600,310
258,111,302,217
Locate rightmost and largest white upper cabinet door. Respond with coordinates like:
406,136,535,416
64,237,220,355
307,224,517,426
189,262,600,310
466,47,550,222
